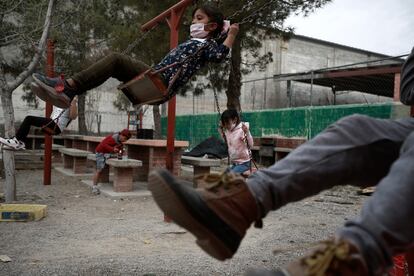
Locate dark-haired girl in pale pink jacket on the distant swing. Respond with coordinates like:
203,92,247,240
219,109,253,174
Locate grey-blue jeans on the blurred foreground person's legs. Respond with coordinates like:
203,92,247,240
247,115,414,274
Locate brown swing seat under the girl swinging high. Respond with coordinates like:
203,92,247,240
118,69,168,105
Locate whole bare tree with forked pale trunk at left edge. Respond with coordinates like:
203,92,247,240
0,0,55,202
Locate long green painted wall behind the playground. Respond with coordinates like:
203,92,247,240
161,103,409,148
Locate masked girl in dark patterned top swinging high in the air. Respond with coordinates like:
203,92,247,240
32,5,239,108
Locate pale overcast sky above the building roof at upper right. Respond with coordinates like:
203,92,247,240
286,0,414,56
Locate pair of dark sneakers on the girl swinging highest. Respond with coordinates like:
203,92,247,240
31,73,77,108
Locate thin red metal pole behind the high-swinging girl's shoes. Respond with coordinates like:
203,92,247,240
43,39,55,185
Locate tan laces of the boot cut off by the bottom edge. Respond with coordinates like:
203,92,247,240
302,240,351,276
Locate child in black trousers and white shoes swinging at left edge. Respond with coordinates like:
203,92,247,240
0,92,78,150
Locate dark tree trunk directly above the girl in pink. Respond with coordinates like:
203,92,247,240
226,38,241,111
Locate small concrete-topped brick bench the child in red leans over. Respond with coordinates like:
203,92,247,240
106,158,142,192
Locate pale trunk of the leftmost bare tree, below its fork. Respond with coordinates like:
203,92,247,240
0,91,16,203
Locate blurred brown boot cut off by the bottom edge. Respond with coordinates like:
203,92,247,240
246,239,372,276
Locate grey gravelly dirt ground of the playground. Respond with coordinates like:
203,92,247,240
0,167,366,275
